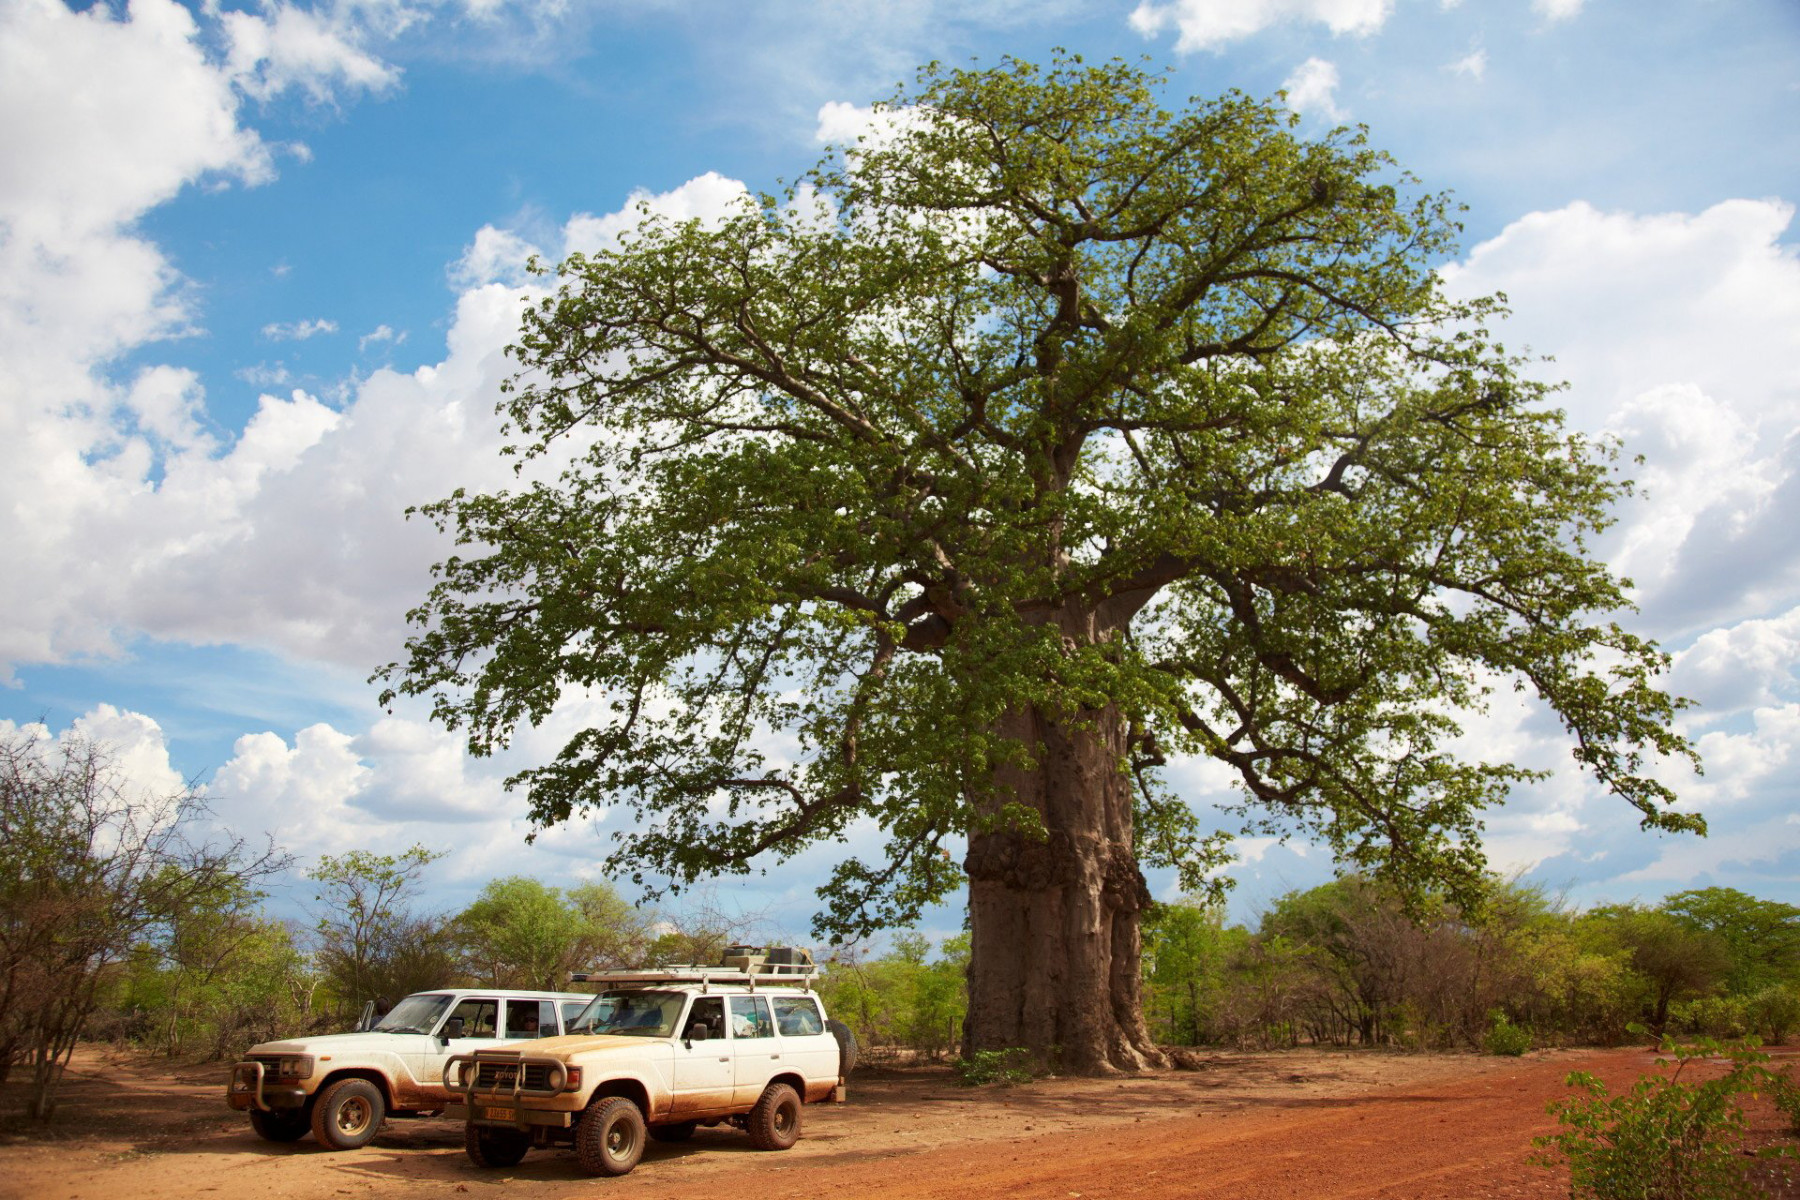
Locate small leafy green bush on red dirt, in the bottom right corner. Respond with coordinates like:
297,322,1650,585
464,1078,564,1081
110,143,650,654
1534,1038,1777,1200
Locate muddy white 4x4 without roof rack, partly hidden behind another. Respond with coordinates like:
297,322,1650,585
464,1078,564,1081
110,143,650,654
225,988,594,1150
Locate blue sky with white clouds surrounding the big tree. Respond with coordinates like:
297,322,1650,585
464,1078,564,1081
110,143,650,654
0,0,1800,936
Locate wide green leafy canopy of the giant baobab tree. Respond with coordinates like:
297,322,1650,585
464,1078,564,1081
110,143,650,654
382,58,1701,934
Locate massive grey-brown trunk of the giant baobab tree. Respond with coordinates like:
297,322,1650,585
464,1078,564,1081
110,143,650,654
963,707,1166,1074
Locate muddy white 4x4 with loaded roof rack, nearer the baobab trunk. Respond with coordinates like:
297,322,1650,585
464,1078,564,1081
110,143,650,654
445,968,855,1175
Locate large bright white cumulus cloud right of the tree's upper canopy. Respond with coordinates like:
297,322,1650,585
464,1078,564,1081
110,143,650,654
1444,200,1800,644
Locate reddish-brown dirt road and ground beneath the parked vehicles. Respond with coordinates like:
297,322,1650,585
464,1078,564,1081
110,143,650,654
0,1051,1800,1200
